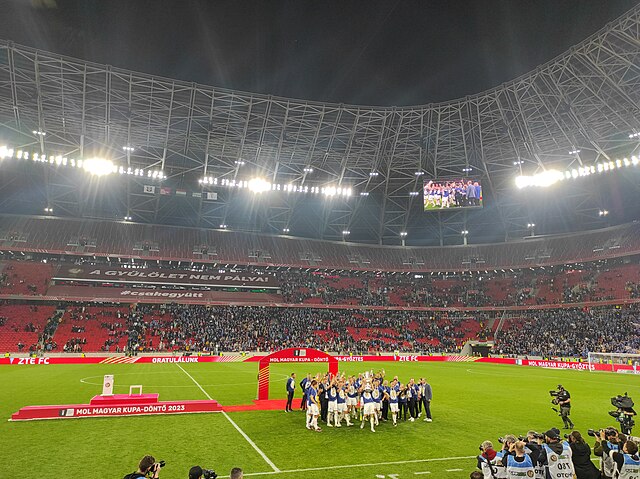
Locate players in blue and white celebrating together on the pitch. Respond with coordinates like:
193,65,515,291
300,370,432,432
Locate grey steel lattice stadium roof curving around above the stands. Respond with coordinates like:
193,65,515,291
0,5,640,245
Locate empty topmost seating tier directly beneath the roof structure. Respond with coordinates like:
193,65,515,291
0,216,640,272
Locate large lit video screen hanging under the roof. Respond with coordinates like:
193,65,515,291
423,178,482,211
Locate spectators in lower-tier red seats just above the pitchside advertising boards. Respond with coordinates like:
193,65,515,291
0,304,640,357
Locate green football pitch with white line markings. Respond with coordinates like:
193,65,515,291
0,362,640,479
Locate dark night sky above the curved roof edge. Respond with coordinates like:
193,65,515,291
0,0,637,105
